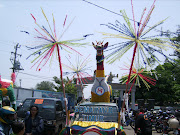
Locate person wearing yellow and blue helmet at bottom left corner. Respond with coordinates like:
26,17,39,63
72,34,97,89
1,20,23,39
0,106,16,135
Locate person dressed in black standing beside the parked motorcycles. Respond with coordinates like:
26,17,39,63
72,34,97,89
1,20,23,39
135,108,152,135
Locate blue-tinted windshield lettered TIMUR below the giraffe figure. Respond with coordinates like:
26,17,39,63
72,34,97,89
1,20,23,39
75,105,118,122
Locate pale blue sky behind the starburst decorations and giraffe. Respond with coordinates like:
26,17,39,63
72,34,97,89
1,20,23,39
0,0,180,88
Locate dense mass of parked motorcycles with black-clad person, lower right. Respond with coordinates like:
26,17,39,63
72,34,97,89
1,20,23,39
123,107,180,135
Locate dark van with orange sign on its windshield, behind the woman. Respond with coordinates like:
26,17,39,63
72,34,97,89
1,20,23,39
17,98,66,134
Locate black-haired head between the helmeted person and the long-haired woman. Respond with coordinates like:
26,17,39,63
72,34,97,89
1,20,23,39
11,121,25,134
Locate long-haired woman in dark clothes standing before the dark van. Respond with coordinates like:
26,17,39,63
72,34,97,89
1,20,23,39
24,105,44,135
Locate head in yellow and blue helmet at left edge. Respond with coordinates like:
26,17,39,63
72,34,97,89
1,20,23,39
0,106,16,124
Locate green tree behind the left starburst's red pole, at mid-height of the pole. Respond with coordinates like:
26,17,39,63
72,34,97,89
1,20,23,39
53,76,77,95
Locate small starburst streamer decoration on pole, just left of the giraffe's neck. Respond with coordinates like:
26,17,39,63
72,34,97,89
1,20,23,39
63,55,92,100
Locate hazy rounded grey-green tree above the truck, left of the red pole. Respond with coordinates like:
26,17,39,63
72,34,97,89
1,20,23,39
36,81,55,91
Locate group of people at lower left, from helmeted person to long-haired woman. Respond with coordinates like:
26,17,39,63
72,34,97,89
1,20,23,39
0,98,44,135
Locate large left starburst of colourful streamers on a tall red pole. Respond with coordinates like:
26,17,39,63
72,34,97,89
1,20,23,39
22,8,87,126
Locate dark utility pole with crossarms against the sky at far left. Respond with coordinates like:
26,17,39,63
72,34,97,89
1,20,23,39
10,43,24,73
